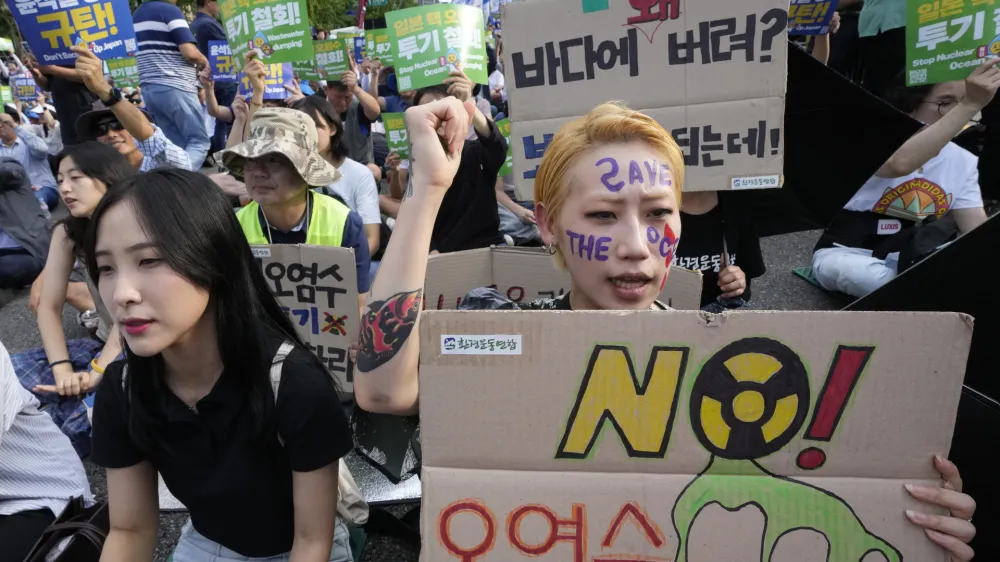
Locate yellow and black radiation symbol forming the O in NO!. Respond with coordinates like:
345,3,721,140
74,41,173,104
690,338,809,459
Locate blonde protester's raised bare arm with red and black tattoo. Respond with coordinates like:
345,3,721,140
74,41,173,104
354,97,476,415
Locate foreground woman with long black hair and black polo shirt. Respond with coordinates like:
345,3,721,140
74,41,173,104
86,169,352,562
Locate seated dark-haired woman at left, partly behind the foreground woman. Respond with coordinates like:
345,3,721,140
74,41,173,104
11,141,135,457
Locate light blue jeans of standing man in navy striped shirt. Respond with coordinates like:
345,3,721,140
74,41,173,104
142,83,211,171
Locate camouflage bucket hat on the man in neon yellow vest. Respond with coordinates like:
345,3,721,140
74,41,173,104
215,107,340,187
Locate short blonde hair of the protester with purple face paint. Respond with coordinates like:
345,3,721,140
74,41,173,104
535,102,684,268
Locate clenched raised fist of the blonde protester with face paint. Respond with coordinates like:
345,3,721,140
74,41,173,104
406,96,476,194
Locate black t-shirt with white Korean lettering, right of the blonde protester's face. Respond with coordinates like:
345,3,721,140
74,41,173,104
673,199,765,306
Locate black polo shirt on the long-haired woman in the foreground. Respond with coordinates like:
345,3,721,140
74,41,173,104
92,339,353,557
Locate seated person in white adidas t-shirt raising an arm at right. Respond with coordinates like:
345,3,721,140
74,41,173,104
813,58,1000,297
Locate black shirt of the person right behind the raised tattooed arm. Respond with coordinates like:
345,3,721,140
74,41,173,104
430,119,507,254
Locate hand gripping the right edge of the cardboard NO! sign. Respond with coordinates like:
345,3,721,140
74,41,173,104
906,456,976,562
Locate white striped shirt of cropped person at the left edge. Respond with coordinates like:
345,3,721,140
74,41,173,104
0,345,93,517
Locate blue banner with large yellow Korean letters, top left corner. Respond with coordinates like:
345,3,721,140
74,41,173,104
7,0,136,65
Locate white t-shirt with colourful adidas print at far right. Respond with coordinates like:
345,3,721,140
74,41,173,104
844,143,983,221
